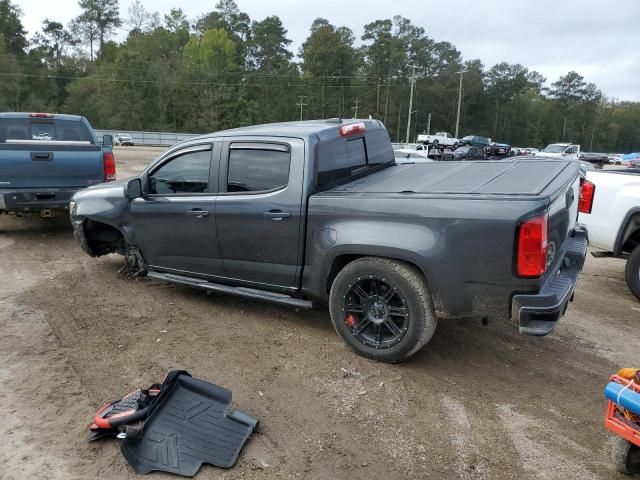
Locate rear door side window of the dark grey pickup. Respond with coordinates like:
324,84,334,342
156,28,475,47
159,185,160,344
227,143,291,193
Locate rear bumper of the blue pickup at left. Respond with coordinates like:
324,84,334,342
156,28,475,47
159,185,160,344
0,188,80,213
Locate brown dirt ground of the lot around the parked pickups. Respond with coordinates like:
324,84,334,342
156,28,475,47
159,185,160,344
0,148,640,479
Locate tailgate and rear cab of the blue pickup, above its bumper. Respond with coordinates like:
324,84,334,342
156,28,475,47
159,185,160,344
0,115,104,188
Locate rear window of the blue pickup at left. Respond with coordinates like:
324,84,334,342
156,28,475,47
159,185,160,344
0,118,93,144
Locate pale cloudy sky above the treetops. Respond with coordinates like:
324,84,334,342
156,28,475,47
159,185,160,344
13,0,640,101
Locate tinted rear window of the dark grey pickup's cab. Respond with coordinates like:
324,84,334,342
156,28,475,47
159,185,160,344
317,129,394,188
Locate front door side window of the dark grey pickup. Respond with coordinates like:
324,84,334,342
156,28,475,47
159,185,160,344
149,148,211,195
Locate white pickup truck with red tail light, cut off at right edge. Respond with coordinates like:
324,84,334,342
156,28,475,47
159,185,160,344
578,170,640,299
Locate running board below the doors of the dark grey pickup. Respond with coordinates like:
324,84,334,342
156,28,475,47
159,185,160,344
147,272,313,309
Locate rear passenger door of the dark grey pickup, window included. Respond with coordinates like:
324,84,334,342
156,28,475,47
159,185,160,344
216,137,304,288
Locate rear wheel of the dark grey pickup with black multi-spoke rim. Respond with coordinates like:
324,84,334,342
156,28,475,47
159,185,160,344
329,257,438,363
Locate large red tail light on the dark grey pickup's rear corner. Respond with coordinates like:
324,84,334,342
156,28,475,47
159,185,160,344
517,212,549,277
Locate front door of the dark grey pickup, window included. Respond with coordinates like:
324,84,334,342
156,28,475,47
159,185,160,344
131,143,223,276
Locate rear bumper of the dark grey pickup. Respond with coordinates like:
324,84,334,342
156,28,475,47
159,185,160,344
511,226,588,335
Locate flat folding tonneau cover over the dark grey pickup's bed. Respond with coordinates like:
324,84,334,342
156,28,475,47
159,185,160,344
327,159,579,195
